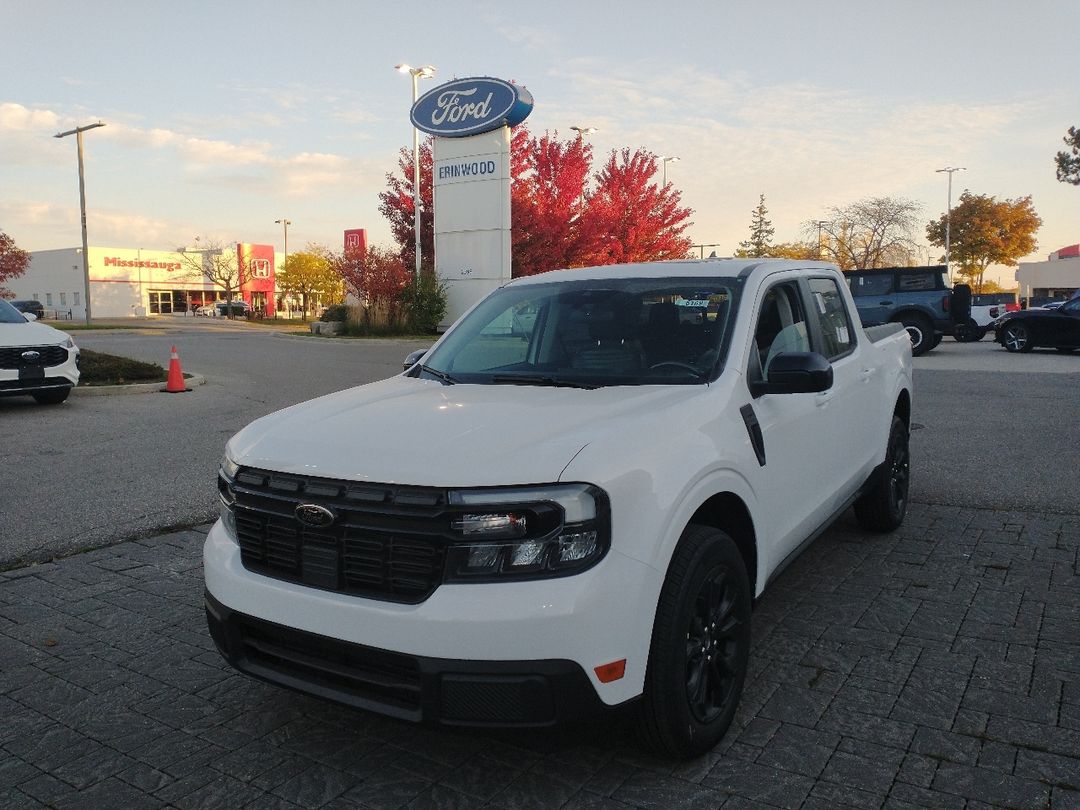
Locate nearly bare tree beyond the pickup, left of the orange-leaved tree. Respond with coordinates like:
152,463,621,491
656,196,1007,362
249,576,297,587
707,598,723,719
804,197,921,270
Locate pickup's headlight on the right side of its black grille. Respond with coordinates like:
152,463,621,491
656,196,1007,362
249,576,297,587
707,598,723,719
446,484,611,582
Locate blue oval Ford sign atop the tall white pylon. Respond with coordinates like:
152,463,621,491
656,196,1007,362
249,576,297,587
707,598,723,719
409,77,532,138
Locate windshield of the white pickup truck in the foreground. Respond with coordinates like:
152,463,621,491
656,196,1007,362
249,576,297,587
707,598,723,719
414,278,741,388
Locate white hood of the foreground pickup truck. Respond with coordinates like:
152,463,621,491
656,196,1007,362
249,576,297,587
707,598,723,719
228,377,698,487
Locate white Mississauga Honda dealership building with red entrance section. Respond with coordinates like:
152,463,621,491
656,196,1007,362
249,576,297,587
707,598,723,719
6,243,278,320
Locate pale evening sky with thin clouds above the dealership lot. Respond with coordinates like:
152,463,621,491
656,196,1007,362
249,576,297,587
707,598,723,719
0,0,1080,285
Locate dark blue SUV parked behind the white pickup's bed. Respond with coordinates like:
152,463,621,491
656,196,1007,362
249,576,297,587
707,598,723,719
845,265,971,356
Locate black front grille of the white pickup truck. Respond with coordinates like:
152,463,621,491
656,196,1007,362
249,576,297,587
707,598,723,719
219,468,453,604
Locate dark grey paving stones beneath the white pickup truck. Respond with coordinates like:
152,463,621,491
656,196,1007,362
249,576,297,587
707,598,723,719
0,504,1080,810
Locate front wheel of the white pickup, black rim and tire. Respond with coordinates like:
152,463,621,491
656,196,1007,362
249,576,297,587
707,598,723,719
639,525,751,758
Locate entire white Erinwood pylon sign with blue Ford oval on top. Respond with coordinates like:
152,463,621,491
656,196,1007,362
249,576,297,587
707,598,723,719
411,78,532,326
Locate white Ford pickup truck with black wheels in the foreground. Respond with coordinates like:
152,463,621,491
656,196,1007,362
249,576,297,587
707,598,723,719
204,259,912,757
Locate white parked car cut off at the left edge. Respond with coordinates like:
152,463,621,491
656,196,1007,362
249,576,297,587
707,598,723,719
0,299,79,405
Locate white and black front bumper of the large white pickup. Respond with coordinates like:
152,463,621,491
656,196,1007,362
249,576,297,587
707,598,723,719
203,523,662,726
